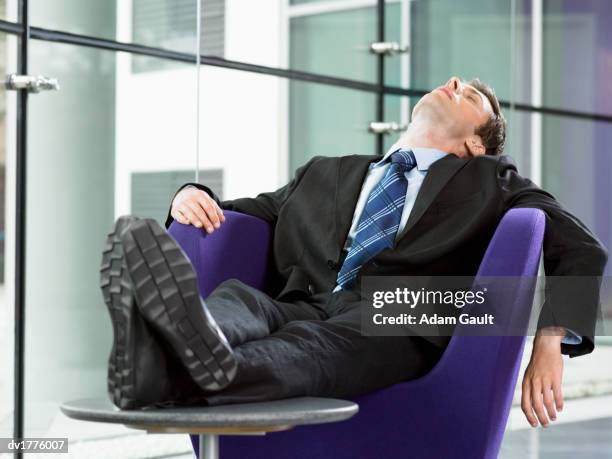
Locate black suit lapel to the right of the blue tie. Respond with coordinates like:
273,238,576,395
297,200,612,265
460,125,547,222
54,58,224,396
399,154,467,240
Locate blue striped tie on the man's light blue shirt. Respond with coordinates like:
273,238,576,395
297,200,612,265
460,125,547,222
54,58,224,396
336,150,416,290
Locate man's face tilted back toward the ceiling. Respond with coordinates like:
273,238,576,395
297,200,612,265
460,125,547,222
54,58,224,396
412,77,493,155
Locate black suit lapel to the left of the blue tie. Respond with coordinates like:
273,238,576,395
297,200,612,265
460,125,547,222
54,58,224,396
335,155,381,253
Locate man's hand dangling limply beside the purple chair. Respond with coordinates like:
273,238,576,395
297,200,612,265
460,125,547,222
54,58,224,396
521,327,565,427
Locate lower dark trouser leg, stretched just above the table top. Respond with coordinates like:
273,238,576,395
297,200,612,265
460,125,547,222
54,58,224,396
205,306,443,405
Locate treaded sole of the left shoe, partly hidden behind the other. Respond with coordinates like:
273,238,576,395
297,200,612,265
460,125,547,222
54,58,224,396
100,216,138,409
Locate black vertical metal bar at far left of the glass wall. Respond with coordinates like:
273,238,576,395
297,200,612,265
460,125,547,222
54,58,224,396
13,0,30,459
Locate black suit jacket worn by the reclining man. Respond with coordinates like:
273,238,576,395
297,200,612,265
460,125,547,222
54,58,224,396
166,154,607,356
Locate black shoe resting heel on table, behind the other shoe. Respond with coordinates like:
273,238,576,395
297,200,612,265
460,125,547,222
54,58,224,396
100,216,201,409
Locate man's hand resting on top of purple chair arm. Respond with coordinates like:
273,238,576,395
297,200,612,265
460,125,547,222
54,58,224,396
170,186,225,234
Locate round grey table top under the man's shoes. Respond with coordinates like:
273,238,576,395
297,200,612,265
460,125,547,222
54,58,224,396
61,397,359,433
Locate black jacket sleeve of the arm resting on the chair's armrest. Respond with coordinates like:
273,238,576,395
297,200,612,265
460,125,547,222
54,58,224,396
166,157,319,228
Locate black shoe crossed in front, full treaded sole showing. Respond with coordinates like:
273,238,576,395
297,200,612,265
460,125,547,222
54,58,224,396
122,219,236,391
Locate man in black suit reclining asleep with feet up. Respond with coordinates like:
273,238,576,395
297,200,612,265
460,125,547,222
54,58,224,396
102,77,607,432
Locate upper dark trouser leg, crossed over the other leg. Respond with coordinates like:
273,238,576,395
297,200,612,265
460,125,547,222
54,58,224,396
205,279,327,347
